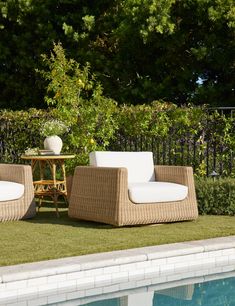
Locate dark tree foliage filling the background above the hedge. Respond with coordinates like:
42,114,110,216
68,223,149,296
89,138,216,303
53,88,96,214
0,0,235,108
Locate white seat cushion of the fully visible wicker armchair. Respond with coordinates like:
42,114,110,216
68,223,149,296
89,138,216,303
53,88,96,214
128,182,188,203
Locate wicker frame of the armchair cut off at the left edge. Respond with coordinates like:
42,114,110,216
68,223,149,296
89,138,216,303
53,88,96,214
0,164,36,221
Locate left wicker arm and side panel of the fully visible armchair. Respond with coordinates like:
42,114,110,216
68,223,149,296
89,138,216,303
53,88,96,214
69,166,128,222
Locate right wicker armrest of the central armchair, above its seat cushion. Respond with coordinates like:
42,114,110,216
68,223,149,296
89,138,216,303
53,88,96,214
154,166,194,187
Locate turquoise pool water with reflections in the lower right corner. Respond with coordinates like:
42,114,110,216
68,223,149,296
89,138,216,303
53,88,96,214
77,277,235,306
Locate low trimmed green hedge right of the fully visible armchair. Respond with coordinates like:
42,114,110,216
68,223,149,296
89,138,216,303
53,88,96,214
196,178,235,216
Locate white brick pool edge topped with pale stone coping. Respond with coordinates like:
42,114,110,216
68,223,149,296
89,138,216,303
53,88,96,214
0,236,235,305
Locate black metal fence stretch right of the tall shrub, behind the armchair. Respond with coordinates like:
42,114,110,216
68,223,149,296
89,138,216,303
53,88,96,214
110,107,235,176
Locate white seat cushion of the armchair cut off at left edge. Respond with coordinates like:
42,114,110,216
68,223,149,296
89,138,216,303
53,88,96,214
0,181,24,202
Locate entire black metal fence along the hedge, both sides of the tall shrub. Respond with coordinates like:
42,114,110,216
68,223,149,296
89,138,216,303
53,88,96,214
0,107,235,176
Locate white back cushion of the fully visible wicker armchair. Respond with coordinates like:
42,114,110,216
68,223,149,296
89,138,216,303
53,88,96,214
89,151,155,183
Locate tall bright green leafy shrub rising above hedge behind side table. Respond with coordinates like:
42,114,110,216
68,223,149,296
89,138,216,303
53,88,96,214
40,44,117,168
